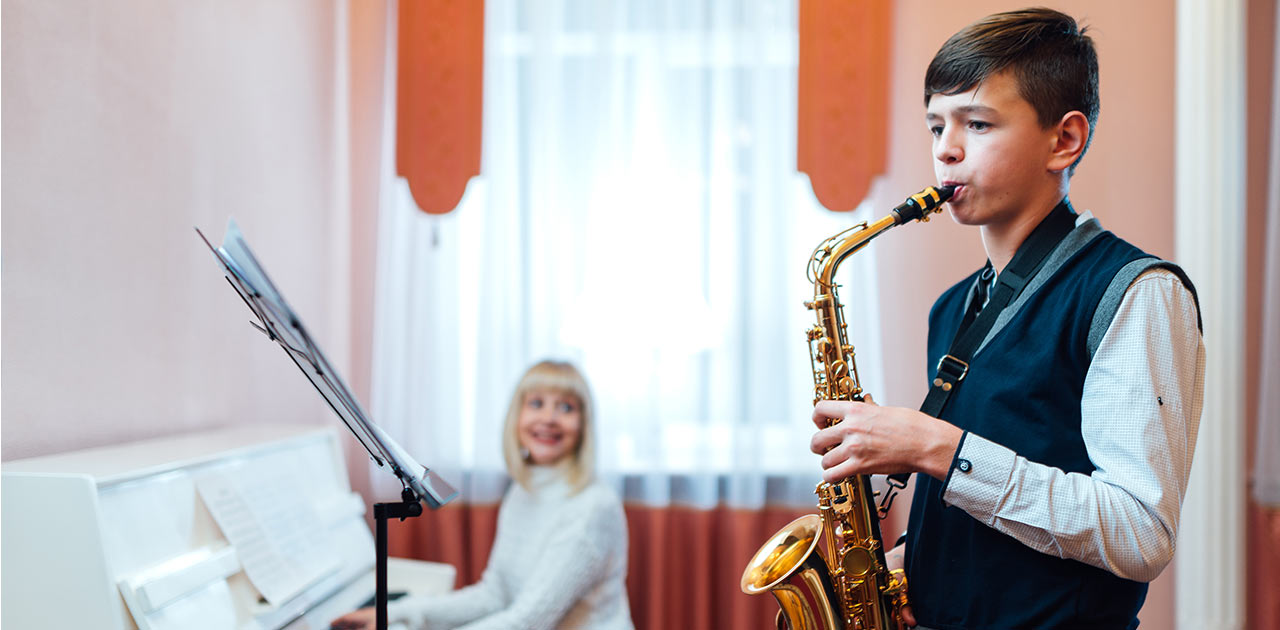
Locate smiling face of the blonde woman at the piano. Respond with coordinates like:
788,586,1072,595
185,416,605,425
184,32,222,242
516,389,582,466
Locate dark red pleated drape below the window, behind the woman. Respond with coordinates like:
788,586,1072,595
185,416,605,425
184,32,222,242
387,505,812,630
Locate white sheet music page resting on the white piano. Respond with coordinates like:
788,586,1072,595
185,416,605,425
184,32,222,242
196,464,338,606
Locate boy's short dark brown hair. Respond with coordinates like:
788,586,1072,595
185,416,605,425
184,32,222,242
924,8,1101,172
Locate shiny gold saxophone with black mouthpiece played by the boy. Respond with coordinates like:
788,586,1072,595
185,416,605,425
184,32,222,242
741,186,955,630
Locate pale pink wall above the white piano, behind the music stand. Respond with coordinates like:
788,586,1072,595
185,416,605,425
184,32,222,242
0,0,345,460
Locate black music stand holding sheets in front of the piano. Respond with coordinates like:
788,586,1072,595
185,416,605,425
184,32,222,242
196,219,458,630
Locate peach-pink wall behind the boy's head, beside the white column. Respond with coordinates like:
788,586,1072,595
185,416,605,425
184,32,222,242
870,0,1174,629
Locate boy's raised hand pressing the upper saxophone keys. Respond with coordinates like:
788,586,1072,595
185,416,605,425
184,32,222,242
809,398,964,483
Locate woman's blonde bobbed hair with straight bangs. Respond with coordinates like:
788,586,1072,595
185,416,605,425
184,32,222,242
502,361,595,492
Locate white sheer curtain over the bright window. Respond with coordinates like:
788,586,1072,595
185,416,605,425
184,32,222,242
371,0,881,507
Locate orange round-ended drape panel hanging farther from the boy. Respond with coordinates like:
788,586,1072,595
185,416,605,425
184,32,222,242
396,0,484,214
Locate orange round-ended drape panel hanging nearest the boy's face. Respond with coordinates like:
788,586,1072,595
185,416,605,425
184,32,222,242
796,0,892,211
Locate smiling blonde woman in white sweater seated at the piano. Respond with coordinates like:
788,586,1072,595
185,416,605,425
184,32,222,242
333,361,632,630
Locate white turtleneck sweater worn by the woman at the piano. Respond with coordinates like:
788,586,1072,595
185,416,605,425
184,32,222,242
388,466,634,630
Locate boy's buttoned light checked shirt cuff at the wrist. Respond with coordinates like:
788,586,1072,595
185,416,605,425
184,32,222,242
942,432,1018,525
